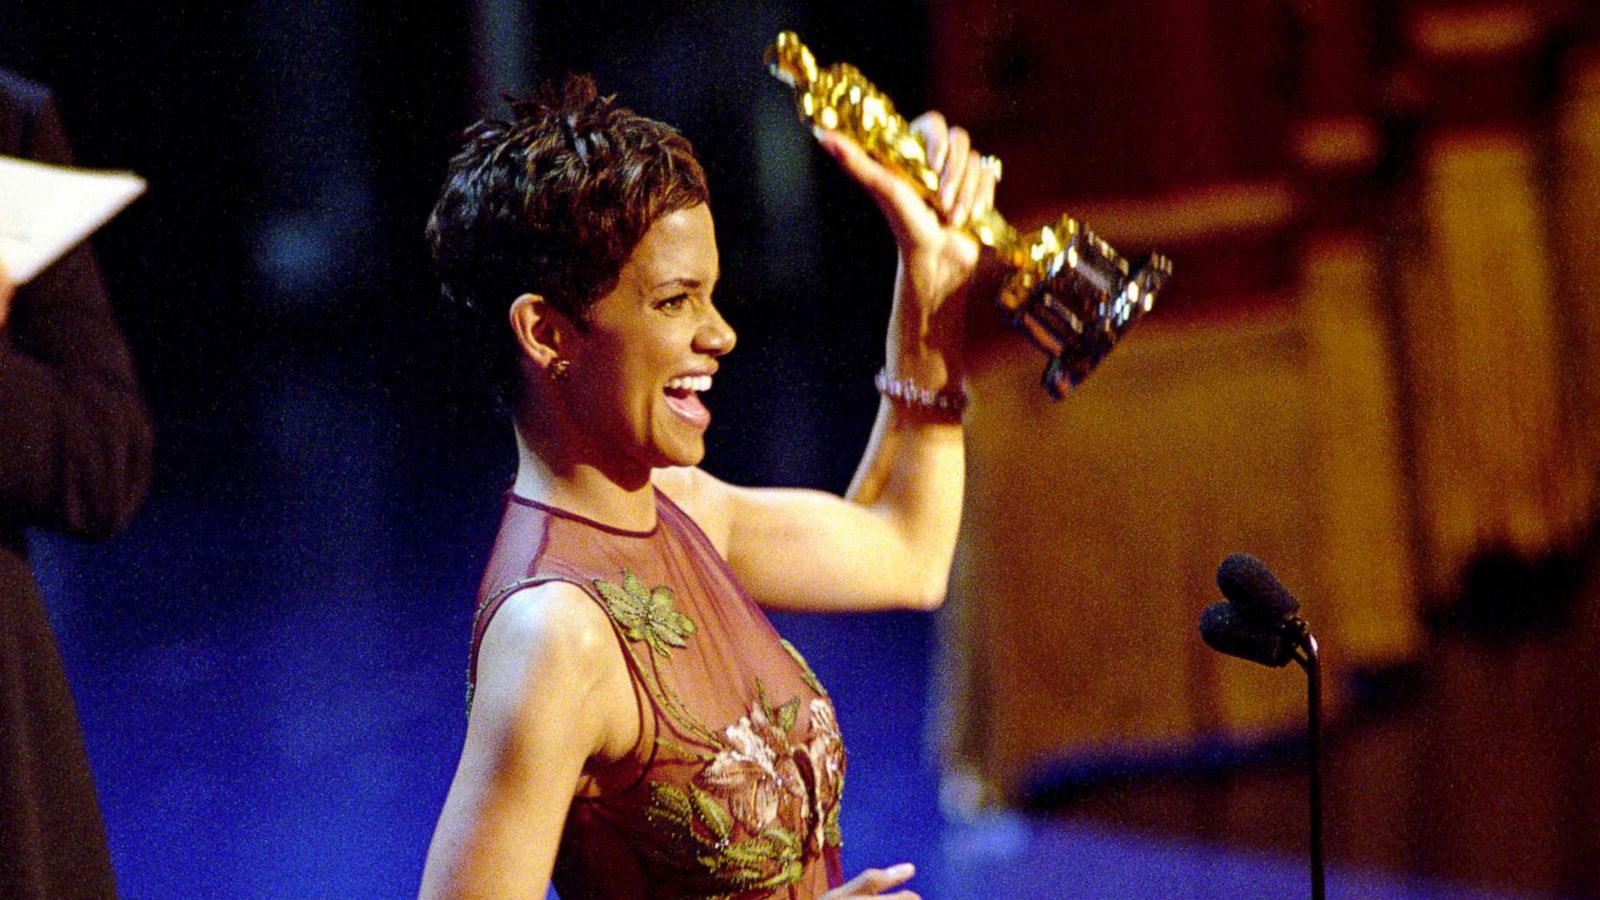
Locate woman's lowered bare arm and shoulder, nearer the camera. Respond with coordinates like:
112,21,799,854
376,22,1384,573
421,583,638,898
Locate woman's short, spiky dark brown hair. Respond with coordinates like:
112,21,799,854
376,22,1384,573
427,75,709,404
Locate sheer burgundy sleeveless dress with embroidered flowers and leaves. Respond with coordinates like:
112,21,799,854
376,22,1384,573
467,490,845,900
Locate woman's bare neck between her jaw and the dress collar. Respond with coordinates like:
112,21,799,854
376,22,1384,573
512,421,656,532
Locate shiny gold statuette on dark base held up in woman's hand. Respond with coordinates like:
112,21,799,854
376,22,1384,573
766,32,1173,400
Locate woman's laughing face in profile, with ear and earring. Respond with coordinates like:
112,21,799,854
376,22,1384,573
563,203,734,476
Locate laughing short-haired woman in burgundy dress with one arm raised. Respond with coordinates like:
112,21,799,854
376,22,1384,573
422,78,994,900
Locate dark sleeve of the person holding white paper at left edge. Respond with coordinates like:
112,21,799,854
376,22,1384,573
0,87,152,536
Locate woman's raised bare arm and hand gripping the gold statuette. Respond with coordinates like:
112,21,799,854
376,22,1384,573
658,114,994,612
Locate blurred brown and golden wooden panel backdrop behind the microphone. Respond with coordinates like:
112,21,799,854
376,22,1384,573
933,0,1600,801
